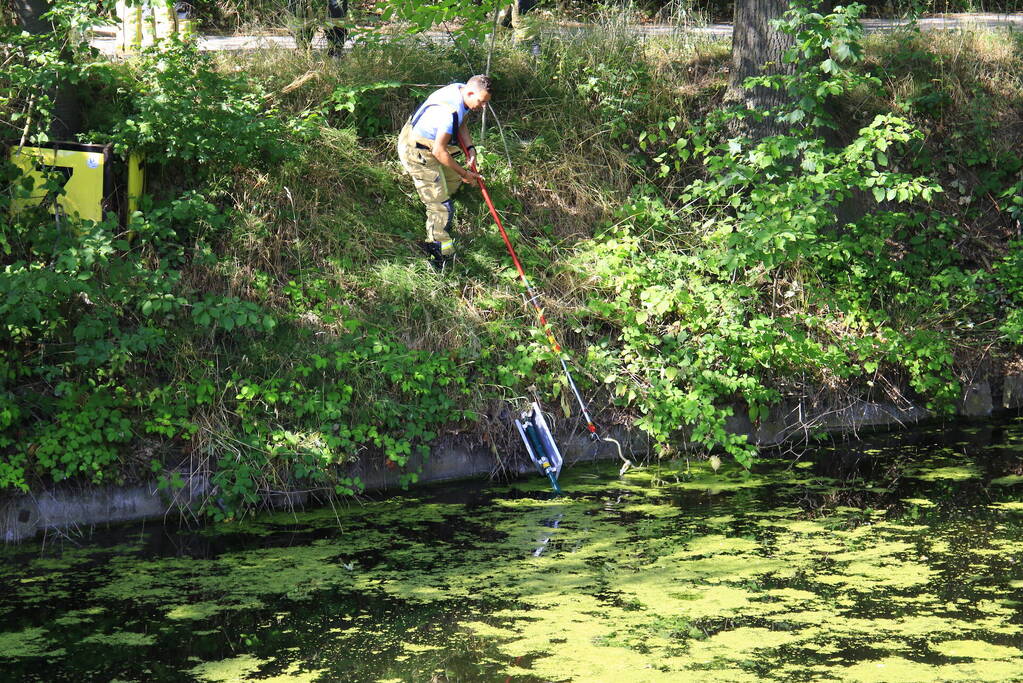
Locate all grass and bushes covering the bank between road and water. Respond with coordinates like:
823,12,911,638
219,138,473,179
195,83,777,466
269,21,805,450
0,1,1023,516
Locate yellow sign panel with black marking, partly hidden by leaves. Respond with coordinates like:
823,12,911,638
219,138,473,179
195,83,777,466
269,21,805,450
10,142,113,221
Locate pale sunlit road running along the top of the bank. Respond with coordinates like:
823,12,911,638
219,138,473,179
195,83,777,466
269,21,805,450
90,13,1023,54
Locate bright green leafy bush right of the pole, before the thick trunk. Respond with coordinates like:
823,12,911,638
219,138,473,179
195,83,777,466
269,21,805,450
580,4,983,465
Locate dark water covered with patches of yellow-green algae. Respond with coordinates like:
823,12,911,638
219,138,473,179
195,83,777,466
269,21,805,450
0,421,1023,682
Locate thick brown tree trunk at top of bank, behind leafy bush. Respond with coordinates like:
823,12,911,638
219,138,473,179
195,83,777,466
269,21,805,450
725,0,793,116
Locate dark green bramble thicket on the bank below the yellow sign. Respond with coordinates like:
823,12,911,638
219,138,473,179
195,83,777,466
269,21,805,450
0,187,472,517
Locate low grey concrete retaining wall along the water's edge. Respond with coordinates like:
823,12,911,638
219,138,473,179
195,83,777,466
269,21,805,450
0,375,1023,542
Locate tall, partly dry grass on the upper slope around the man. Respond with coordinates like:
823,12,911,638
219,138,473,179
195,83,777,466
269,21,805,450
195,19,1010,376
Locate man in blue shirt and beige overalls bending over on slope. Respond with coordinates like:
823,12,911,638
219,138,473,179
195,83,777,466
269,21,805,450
398,76,492,270
